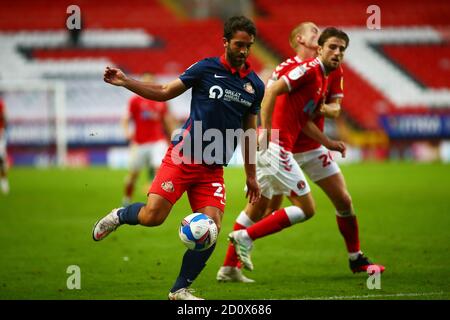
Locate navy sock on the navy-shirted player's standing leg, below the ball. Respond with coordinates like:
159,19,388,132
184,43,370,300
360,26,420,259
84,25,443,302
170,244,216,292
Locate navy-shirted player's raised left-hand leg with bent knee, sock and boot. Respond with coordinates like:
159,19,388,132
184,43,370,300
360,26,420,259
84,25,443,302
92,193,172,241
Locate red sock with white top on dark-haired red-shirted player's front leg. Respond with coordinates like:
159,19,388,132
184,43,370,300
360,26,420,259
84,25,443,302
247,206,306,240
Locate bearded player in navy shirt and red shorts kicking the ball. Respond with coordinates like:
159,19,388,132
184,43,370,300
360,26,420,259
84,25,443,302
92,16,264,300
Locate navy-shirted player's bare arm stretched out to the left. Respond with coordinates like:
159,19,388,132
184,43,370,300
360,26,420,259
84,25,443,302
103,67,187,101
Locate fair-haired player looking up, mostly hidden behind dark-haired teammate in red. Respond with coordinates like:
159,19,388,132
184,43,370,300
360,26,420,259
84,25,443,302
217,22,384,282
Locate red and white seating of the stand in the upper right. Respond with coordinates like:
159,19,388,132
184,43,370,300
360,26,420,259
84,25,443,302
256,0,450,130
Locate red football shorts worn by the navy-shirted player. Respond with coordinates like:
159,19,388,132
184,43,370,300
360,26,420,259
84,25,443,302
148,148,226,212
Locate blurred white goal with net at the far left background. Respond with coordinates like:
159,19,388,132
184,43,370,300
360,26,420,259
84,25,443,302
0,79,67,167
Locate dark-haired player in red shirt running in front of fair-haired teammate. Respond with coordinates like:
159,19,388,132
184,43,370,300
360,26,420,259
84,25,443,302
223,28,349,276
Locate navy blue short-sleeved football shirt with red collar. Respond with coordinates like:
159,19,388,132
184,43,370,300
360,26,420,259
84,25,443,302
172,56,264,165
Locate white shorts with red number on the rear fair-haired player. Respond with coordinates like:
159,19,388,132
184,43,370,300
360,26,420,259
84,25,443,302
294,146,341,182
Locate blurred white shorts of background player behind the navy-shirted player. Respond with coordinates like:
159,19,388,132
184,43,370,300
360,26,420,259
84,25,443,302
130,140,167,171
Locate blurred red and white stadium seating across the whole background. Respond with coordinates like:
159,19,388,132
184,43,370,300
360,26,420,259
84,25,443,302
0,0,450,165
